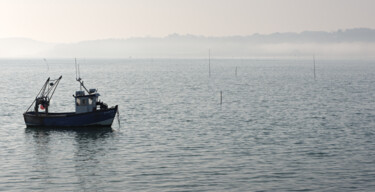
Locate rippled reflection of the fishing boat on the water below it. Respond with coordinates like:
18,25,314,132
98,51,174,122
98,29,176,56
25,127,116,191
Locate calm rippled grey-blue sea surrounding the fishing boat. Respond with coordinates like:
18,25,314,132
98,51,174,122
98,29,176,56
0,59,375,191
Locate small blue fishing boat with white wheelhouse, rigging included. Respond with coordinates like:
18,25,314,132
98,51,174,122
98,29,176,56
23,76,118,128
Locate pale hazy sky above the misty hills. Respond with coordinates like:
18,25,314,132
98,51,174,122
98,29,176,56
0,0,375,43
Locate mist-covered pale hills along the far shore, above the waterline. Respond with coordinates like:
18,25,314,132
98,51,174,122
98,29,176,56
0,28,375,58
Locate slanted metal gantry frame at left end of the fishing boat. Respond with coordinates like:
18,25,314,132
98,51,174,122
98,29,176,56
26,76,62,113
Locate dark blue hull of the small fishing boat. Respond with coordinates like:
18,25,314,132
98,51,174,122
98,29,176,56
23,105,118,127
